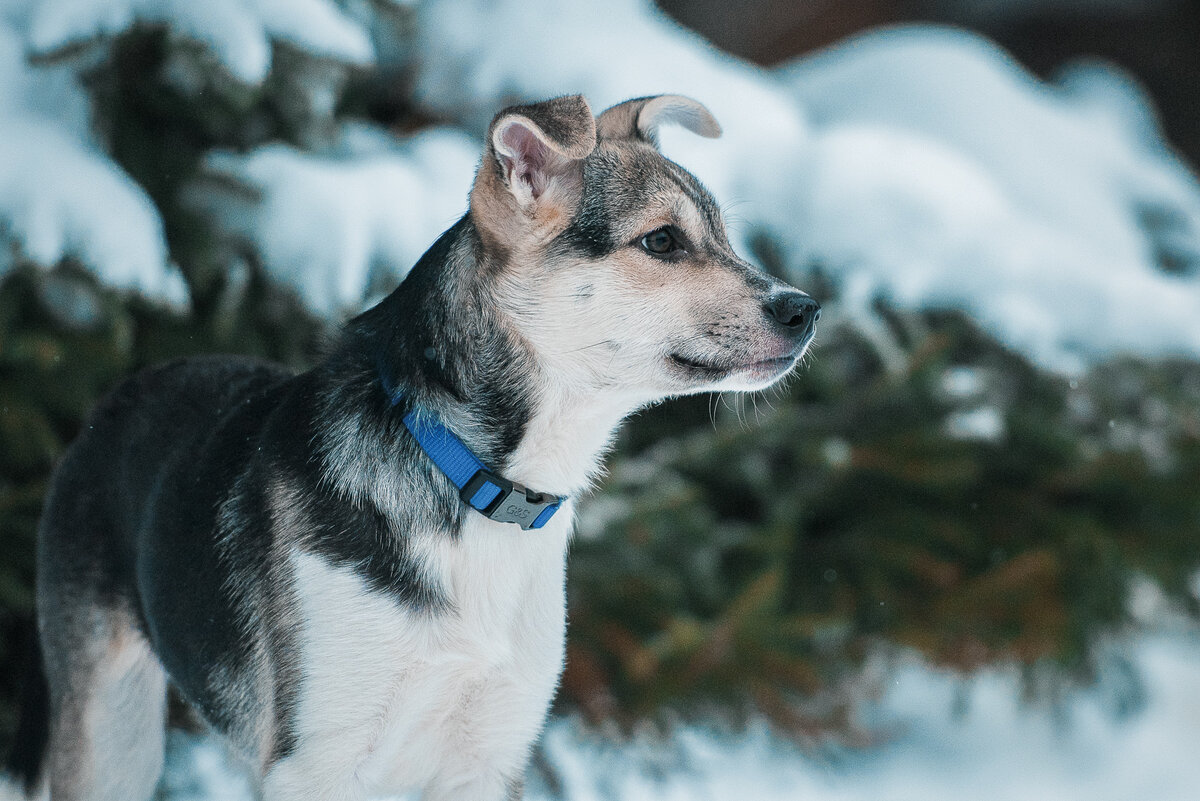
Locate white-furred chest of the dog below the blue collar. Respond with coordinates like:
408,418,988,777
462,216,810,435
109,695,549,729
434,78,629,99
295,514,568,791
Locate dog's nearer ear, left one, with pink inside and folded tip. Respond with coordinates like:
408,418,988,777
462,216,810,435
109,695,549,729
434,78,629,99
475,95,596,211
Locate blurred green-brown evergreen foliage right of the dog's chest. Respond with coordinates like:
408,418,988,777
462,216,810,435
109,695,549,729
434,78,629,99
564,314,1200,729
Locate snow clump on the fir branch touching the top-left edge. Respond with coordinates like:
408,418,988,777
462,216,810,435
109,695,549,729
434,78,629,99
29,0,373,85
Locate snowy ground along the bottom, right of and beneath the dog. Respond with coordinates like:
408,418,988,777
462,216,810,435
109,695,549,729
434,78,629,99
157,630,1200,801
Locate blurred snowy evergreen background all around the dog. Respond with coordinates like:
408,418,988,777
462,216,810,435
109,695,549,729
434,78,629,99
0,0,1200,801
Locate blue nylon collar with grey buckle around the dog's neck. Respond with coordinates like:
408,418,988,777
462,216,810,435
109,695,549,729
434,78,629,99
384,384,565,530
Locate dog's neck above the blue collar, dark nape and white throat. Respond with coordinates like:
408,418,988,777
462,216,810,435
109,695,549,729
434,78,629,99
350,217,636,496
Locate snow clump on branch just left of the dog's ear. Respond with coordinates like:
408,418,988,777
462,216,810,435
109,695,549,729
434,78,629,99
190,128,480,317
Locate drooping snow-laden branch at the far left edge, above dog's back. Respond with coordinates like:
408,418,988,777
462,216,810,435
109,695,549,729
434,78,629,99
0,16,187,305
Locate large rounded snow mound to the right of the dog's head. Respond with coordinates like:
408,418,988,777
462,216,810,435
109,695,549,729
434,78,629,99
782,28,1200,369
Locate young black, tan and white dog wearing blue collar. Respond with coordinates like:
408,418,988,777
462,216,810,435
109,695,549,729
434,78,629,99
4,95,820,801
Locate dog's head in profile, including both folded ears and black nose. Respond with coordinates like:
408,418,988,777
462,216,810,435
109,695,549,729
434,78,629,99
472,96,820,403
